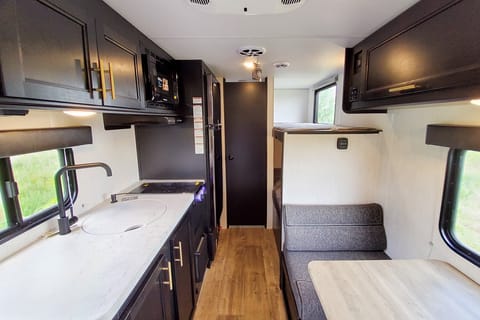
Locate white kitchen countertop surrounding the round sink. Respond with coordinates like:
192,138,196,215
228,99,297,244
0,194,193,320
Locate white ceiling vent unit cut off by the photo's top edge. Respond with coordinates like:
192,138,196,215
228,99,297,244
186,0,306,15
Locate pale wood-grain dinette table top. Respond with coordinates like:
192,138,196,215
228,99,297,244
308,260,480,320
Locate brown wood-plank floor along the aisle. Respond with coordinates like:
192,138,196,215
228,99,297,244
193,228,287,320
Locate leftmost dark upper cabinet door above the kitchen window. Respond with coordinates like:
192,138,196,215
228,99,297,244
0,0,101,104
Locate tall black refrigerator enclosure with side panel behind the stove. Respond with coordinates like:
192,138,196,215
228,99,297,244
135,60,223,263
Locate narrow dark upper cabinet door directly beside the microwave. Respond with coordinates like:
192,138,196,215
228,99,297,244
97,3,144,108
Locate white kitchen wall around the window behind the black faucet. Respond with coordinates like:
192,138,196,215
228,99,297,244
0,110,139,260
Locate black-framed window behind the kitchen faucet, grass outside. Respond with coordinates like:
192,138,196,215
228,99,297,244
0,149,76,241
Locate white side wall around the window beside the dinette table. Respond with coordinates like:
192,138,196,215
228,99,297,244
337,95,480,282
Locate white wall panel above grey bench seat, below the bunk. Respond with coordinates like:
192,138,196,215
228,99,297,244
283,134,381,204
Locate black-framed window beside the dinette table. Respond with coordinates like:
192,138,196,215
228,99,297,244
440,149,480,266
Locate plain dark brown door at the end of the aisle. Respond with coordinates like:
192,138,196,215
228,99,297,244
224,82,267,226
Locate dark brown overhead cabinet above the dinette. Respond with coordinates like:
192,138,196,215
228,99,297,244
344,0,480,112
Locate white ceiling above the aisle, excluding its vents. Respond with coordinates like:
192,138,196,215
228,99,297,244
104,0,417,88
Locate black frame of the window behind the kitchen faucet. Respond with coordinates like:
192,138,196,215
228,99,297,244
0,148,78,244
